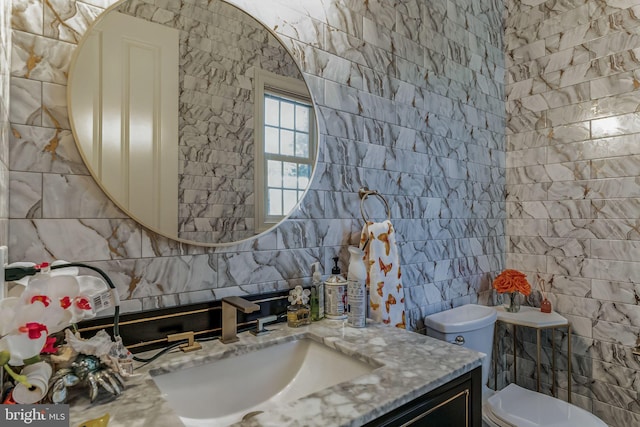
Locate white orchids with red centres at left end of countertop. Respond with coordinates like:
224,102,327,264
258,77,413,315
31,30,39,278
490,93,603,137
0,262,117,403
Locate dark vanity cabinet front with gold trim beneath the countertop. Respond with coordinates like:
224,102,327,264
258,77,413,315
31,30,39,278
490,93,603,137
365,367,482,427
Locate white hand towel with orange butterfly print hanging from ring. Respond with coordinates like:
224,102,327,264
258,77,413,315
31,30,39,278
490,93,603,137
360,220,406,329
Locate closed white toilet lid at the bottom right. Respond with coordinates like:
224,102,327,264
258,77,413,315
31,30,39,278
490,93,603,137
485,384,607,427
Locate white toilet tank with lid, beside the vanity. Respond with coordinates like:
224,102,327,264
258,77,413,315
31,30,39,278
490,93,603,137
424,304,498,384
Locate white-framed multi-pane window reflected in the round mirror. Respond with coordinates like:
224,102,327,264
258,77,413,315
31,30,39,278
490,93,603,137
255,70,316,231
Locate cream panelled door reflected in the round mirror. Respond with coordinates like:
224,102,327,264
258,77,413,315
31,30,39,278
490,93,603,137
70,12,179,236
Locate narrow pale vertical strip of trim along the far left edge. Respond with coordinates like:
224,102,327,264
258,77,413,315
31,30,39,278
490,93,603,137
0,1,11,245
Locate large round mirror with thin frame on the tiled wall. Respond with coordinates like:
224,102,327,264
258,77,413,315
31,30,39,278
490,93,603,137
68,0,317,245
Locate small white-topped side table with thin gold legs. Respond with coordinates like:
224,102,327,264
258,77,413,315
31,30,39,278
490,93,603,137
493,306,571,403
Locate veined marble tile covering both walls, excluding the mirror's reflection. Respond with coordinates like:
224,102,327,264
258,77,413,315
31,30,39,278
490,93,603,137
8,0,640,427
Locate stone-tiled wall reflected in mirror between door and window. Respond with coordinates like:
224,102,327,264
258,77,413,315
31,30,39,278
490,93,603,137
116,0,302,242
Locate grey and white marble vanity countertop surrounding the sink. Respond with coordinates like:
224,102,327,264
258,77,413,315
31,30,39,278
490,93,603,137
69,320,483,427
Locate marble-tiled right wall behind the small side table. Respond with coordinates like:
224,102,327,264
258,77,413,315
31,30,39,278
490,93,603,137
505,0,640,427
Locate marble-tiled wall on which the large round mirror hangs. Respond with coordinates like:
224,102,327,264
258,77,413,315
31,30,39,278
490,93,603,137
9,0,506,330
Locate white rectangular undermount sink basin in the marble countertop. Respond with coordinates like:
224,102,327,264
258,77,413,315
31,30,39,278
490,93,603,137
151,338,380,427
